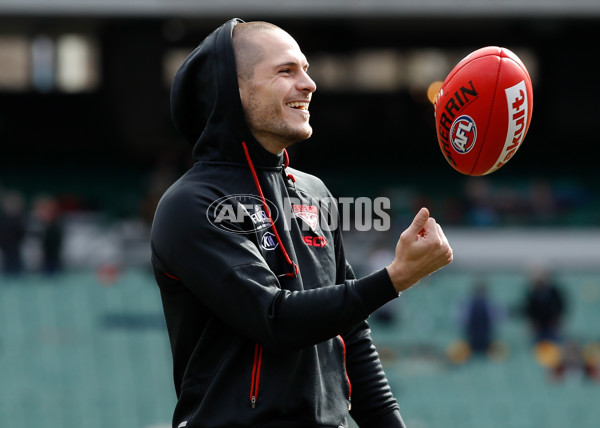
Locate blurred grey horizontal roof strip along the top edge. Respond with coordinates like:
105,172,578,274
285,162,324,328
0,0,600,17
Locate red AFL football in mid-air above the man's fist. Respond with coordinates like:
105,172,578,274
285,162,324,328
435,46,533,175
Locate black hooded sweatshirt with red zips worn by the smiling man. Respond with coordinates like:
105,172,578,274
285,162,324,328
151,19,404,428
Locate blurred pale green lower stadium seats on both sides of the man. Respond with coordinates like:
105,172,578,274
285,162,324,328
0,269,600,428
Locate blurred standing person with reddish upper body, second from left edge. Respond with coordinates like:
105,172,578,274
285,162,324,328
34,197,63,275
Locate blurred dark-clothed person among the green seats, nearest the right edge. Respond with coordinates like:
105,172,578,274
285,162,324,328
523,268,566,343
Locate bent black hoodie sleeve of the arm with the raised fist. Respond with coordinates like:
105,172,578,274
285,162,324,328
152,184,396,349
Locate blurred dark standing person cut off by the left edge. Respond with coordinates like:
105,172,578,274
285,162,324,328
0,191,26,275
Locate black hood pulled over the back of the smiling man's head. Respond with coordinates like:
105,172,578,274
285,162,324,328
171,18,283,166
